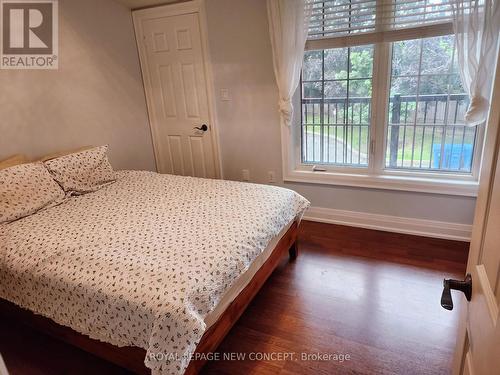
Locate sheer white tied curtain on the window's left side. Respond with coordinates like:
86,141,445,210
267,0,312,126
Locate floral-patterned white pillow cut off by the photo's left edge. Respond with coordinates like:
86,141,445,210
0,163,64,224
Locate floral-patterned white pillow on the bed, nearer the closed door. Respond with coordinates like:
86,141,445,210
45,146,116,195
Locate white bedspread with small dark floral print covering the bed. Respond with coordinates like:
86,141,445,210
0,171,309,374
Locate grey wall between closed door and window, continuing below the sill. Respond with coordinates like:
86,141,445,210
207,0,475,224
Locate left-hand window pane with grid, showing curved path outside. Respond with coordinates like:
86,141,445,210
301,45,373,167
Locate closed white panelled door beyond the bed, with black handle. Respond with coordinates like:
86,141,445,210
136,7,217,178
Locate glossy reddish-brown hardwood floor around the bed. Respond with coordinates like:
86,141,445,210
0,221,468,375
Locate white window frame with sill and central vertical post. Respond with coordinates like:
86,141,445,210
281,23,488,197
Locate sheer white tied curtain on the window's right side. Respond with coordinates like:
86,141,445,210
451,0,500,126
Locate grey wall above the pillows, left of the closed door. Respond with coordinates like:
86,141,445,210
0,0,155,170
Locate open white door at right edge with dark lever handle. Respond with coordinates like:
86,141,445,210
454,60,500,375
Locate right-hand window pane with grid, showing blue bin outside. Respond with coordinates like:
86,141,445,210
385,35,477,173
